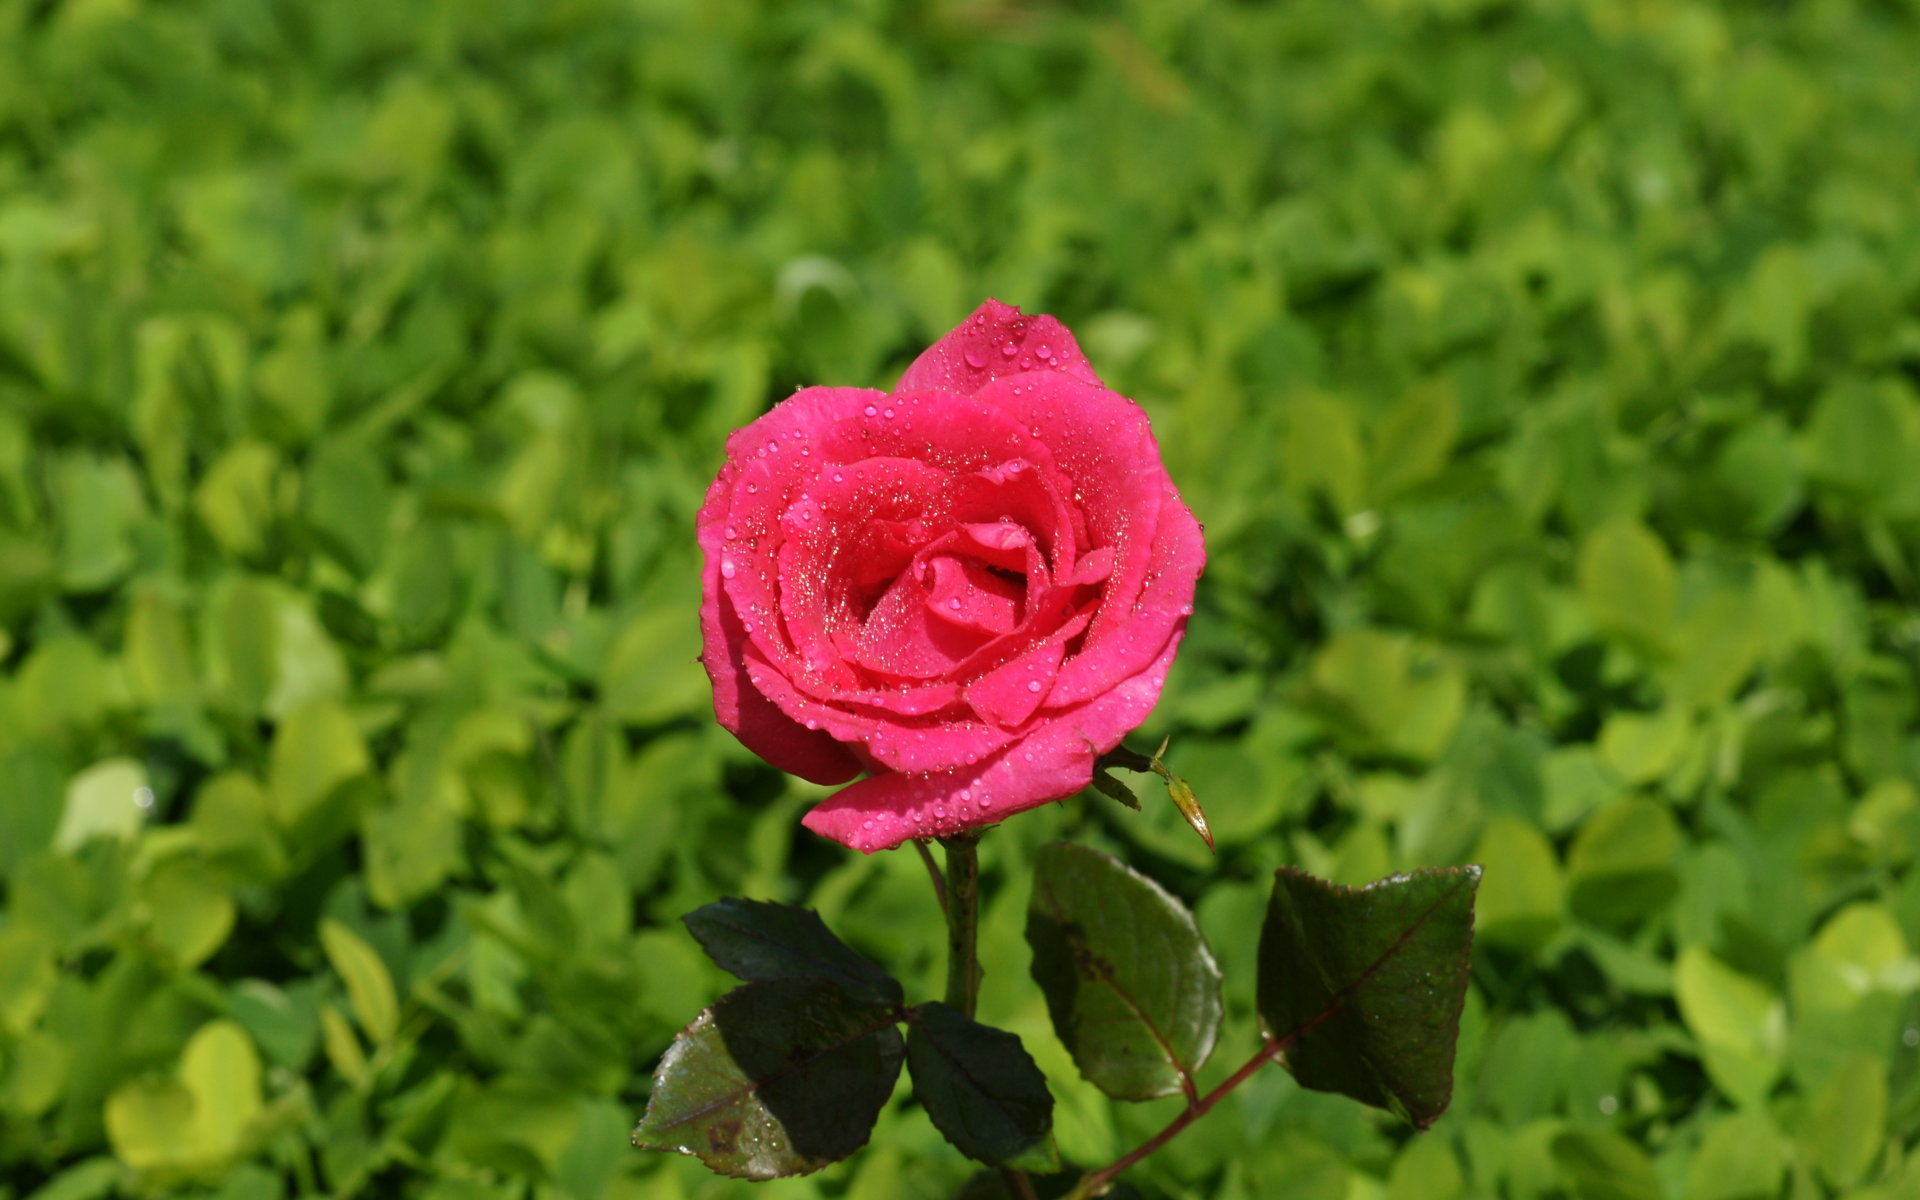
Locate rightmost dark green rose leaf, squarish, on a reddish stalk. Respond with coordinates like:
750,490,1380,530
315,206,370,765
1260,866,1480,1129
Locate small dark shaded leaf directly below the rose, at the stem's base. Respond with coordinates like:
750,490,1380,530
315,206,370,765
906,1002,1060,1173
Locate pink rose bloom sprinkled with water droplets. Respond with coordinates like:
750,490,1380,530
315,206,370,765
699,300,1206,852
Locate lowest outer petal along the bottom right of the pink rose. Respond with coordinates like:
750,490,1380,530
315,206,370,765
801,634,1181,854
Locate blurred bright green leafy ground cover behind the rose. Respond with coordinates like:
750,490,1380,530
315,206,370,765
0,0,1920,1200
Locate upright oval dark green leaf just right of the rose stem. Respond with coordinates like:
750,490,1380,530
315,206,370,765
1027,841,1221,1100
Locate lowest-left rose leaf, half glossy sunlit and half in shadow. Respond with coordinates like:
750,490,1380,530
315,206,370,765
634,979,902,1179
